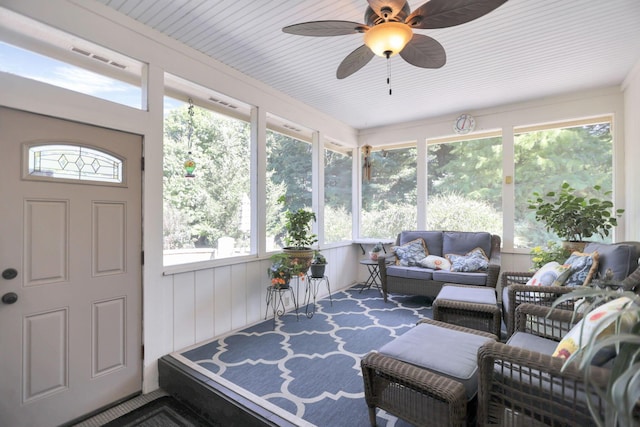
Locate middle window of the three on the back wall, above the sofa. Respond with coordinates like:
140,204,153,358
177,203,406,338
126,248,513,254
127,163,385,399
426,135,502,236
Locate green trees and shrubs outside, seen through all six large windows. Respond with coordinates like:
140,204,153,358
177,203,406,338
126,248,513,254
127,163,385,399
163,105,612,262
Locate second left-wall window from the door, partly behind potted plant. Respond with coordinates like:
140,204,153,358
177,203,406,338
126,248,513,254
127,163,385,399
266,124,312,251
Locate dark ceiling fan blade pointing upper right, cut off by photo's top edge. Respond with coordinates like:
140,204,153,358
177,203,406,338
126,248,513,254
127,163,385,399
405,0,507,28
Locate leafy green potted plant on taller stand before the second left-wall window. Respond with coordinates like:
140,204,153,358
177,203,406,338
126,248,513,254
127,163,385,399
278,196,318,268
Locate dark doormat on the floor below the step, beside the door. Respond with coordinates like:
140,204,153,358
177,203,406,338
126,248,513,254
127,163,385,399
105,396,214,427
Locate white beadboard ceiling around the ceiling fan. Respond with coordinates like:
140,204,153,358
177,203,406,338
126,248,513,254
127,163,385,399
91,0,640,129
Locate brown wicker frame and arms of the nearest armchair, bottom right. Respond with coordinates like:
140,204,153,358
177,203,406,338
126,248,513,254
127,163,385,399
478,304,609,427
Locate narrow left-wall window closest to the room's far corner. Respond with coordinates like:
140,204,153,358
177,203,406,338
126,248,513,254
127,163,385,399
324,144,353,243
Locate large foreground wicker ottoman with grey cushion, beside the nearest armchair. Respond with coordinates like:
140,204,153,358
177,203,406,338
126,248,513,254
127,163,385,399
361,319,495,427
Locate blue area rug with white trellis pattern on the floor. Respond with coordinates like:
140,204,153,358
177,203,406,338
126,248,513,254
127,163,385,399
173,287,431,427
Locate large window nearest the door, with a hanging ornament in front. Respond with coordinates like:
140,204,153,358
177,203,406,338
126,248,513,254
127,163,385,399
163,91,252,266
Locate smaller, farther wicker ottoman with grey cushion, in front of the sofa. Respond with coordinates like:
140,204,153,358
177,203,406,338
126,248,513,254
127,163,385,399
433,284,501,338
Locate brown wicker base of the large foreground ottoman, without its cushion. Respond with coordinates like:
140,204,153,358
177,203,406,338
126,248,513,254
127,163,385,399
361,319,496,427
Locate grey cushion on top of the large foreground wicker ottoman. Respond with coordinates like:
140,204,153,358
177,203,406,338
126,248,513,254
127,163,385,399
379,323,492,400
